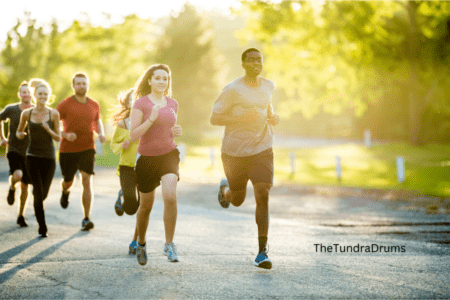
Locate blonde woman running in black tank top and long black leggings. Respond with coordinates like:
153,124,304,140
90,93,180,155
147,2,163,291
16,79,61,238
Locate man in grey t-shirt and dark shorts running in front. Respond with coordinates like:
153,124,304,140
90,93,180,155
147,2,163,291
211,48,279,269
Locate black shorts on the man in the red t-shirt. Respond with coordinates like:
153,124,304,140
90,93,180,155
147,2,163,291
59,149,95,182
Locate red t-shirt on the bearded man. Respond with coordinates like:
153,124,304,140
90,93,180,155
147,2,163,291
56,96,100,153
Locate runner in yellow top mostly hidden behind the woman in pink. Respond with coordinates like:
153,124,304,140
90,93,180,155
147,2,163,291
111,89,139,254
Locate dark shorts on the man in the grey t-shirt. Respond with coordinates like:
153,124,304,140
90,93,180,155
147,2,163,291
222,148,273,191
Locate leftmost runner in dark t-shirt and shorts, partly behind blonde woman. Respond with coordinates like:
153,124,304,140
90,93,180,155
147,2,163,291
0,81,32,227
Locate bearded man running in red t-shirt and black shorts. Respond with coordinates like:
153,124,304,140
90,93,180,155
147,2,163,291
56,73,105,230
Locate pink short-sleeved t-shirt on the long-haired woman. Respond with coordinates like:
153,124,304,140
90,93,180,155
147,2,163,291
133,96,178,156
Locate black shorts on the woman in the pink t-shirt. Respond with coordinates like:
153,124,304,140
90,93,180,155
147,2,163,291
136,148,180,193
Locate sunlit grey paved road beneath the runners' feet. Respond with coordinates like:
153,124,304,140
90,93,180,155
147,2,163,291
0,162,450,299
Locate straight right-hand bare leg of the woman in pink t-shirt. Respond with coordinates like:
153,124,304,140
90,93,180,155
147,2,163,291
161,174,178,245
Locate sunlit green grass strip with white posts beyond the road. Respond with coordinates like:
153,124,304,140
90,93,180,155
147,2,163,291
97,143,450,197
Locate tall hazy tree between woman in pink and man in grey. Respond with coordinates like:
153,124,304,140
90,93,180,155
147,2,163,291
155,4,220,140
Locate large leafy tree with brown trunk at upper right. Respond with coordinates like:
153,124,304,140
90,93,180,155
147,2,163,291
241,1,450,144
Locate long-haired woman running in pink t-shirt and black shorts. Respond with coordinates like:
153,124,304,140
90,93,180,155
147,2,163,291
130,64,182,265
